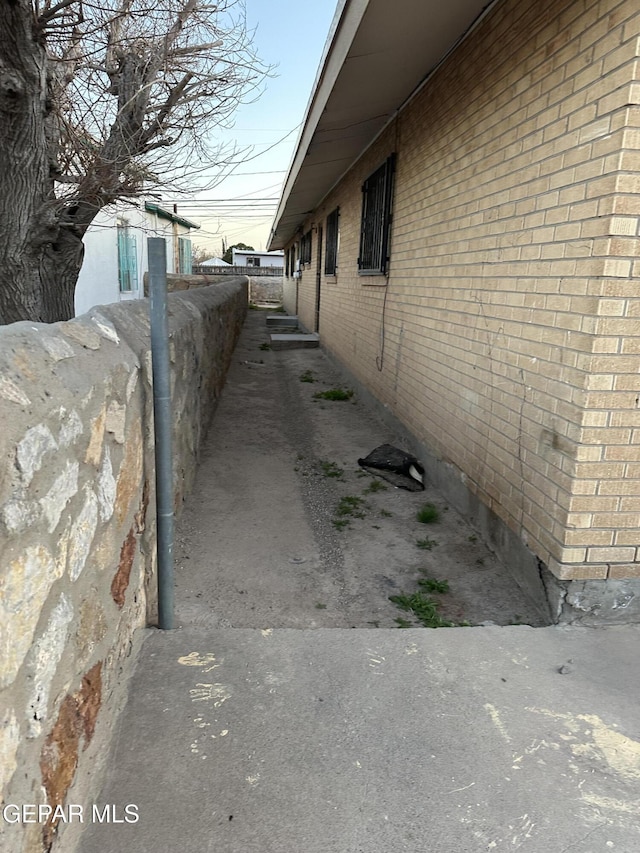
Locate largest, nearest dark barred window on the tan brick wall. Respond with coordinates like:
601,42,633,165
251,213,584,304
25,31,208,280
358,154,396,275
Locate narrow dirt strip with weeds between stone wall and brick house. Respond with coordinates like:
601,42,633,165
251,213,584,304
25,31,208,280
175,310,543,628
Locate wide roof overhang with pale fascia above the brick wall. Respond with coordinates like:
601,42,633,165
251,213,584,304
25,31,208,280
269,0,495,249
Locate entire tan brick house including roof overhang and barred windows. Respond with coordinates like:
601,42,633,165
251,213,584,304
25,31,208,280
269,0,640,619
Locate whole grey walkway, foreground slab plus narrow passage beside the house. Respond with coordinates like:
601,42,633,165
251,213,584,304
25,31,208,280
81,312,640,853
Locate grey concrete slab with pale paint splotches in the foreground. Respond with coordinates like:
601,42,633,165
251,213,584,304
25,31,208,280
81,627,640,853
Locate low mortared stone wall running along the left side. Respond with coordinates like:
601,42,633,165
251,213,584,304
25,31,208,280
0,279,247,853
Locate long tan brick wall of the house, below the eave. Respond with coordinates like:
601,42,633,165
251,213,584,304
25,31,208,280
284,0,640,579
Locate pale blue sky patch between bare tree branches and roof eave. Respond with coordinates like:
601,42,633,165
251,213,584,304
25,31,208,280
163,0,336,257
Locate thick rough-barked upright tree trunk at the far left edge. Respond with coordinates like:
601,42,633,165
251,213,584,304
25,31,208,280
0,0,89,324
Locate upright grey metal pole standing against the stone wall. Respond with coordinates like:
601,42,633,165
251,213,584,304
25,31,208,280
147,237,173,631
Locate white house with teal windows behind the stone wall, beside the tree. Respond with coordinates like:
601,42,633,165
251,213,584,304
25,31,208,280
75,201,200,315
